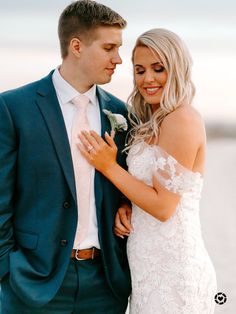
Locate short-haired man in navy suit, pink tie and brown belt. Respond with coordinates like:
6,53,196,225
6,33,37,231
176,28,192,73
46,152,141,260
0,0,130,314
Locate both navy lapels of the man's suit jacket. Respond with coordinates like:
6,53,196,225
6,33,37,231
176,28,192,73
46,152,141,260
36,78,120,213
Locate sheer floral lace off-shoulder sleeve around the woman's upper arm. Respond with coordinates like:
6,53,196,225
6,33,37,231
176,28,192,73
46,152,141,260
154,146,201,196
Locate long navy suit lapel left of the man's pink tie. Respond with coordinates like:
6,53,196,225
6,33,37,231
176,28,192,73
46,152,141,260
36,73,76,202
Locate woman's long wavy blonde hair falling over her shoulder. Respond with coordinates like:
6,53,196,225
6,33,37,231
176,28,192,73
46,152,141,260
127,28,195,148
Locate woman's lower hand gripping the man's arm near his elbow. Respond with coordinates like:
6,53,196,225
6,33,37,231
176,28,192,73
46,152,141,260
114,204,133,239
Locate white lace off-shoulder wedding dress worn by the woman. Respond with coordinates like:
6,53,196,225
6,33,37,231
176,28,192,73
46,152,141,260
127,143,216,314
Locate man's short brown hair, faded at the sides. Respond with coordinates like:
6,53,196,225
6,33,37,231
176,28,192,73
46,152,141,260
58,0,126,58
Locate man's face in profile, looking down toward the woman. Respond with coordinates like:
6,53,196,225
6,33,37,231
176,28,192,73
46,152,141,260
78,26,122,86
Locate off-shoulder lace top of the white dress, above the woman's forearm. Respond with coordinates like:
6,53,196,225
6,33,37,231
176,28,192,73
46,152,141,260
127,142,203,200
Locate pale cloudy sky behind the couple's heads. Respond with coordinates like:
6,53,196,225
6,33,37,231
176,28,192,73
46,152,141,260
0,0,236,123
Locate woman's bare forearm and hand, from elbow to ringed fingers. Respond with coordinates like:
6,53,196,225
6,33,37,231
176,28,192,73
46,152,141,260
79,131,180,221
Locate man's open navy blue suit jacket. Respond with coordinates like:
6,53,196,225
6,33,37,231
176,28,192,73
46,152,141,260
0,73,131,307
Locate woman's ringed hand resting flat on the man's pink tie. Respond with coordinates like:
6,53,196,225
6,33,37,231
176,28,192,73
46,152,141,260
78,131,117,173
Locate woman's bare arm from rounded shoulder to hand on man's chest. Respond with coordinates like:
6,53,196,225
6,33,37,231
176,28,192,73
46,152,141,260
80,106,205,221
